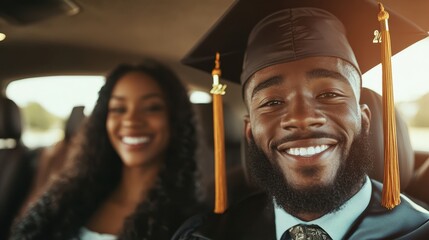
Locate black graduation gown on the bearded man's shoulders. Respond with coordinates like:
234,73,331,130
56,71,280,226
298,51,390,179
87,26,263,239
173,180,429,240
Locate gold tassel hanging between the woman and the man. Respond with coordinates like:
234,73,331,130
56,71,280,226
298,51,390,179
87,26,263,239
210,53,227,214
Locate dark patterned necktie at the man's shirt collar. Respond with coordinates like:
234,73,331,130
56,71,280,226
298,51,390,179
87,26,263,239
280,224,332,240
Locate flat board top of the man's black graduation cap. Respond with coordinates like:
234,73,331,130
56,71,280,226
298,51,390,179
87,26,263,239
182,0,428,83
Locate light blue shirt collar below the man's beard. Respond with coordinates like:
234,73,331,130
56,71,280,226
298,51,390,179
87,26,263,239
274,176,372,240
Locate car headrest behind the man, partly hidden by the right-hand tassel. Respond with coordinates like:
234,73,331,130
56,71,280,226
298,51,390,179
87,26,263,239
360,88,414,189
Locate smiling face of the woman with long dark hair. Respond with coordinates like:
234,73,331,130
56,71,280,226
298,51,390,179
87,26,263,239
106,72,170,167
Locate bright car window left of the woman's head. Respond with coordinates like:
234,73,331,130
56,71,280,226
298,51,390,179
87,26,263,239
6,76,104,148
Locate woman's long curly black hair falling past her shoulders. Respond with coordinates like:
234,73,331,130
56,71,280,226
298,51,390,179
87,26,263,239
11,59,197,240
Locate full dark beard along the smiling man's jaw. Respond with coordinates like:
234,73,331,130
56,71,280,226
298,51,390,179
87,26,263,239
247,130,373,215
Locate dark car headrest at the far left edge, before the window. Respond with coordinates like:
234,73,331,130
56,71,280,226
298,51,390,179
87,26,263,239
0,96,22,142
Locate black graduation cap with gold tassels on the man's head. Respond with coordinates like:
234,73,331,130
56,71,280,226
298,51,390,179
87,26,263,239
182,0,428,210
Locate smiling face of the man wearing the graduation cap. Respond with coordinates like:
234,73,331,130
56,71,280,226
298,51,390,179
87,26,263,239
244,57,370,190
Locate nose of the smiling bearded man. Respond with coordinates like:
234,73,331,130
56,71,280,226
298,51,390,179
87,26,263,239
280,95,327,130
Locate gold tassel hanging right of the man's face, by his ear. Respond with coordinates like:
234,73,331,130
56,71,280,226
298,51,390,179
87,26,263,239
378,3,401,209
